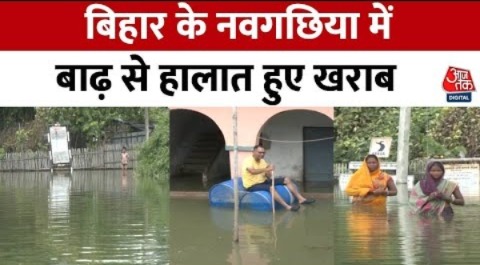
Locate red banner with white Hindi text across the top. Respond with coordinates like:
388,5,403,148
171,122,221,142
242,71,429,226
0,1,480,51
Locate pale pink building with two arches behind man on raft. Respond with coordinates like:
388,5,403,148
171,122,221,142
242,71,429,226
170,107,334,190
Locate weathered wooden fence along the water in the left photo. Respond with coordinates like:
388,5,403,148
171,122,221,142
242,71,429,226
0,144,140,171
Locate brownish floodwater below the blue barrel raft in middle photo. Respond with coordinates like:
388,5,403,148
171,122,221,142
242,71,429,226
170,199,333,265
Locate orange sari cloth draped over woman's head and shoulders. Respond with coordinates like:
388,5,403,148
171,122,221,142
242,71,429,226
345,156,390,205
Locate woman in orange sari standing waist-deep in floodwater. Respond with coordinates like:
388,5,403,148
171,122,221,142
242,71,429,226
345,155,397,206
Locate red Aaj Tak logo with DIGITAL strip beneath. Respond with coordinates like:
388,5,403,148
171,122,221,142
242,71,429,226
443,66,475,102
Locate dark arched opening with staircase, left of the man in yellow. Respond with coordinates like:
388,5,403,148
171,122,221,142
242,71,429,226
170,109,230,191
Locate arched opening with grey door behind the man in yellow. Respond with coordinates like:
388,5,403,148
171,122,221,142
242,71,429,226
258,110,334,189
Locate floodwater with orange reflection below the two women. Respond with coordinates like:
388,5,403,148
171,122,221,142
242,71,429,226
335,184,480,265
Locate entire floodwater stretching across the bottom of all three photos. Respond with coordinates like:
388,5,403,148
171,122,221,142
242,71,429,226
0,171,480,265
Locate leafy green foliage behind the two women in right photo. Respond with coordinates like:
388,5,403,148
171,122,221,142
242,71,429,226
335,108,480,162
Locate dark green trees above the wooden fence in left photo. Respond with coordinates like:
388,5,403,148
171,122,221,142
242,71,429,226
0,108,144,152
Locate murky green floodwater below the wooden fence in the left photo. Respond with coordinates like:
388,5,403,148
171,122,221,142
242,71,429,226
0,171,170,264
